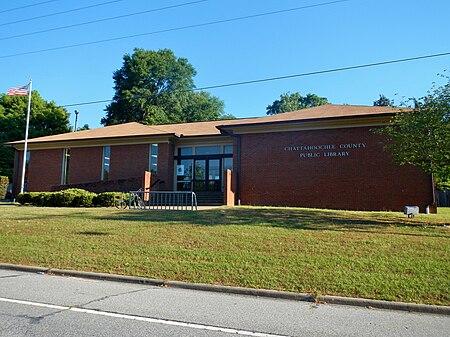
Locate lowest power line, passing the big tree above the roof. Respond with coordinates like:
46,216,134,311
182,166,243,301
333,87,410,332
61,52,450,108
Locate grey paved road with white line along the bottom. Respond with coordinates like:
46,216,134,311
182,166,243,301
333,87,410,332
0,270,450,337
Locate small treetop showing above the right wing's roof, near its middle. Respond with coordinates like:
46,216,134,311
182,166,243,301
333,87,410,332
266,92,328,115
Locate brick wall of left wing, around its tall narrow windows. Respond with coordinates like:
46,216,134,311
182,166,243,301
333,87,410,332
18,144,174,194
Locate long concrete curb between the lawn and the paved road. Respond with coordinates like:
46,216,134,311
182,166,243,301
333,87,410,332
0,263,450,315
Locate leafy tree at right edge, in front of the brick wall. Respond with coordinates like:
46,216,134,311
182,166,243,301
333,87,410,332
377,76,450,188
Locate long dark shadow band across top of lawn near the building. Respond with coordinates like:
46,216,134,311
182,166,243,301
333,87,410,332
93,208,450,236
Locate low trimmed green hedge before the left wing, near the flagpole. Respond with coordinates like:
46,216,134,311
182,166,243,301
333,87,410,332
17,188,119,207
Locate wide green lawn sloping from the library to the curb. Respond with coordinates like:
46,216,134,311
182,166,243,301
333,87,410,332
0,206,450,305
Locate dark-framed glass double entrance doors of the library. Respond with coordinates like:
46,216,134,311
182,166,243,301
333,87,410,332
194,159,222,192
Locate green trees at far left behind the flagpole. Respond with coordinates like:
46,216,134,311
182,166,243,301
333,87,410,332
0,90,70,179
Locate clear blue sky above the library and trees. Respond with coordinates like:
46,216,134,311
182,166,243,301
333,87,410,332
0,0,450,128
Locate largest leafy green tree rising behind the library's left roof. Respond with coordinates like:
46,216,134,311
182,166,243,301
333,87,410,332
101,48,229,125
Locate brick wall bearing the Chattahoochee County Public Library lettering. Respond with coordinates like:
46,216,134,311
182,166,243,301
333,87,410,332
240,127,432,211
